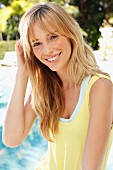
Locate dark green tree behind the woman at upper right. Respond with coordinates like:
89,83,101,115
72,0,105,49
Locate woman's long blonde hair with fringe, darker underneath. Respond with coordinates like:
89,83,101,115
19,2,107,141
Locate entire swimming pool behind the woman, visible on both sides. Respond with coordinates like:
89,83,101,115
0,65,113,170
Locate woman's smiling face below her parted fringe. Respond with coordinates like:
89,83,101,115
31,23,71,72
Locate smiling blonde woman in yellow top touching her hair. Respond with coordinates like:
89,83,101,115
3,2,113,170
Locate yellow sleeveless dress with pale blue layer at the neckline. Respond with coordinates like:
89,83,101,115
36,74,113,170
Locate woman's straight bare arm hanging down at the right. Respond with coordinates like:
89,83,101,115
82,78,113,170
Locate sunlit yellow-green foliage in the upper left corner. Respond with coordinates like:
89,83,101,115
0,0,33,40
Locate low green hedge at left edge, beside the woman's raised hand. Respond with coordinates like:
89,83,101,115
0,40,16,60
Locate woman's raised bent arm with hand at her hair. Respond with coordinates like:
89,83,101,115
2,41,36,147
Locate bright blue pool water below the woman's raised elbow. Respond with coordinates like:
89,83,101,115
0,120,47,170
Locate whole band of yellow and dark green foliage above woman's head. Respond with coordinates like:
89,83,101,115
0,0,113,49
